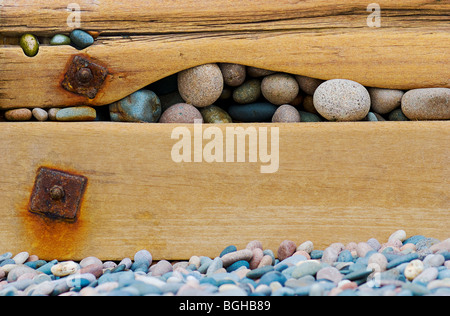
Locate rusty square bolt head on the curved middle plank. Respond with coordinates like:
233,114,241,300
61,55,108,99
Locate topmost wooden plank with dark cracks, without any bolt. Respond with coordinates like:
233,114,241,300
0,0,450,36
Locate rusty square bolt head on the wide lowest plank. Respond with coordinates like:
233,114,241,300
29,167,87,222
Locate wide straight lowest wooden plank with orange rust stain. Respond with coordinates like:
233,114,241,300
0,122,450,260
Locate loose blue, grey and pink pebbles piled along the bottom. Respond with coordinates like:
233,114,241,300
0,230,450,296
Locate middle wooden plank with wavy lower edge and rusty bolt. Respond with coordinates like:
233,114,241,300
0,28,450,109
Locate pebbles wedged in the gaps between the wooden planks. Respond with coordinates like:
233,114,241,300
4,30,450,124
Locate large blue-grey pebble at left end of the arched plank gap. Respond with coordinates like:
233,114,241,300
109,90,161,123
